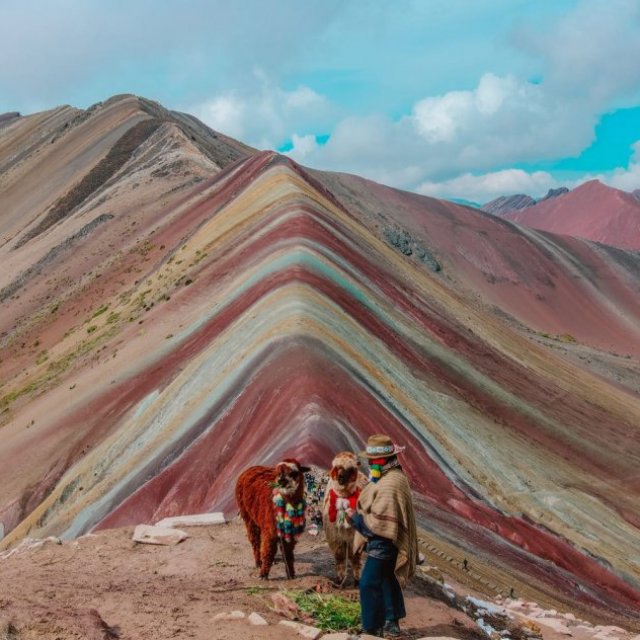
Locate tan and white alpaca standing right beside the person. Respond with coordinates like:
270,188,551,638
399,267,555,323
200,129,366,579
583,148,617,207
322,451,367,585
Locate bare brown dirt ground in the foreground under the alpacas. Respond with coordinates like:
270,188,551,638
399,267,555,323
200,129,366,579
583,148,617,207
0,522,632,640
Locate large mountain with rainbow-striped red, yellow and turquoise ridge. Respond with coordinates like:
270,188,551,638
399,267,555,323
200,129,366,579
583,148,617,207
0,96,640,624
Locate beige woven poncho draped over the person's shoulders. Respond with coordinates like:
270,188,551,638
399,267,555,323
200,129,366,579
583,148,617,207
355,469,418,588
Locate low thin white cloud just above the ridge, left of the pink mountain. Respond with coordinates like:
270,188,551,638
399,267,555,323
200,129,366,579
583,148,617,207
416,169,559,204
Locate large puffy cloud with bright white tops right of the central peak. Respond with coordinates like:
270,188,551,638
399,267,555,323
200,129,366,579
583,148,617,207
296,73,596,189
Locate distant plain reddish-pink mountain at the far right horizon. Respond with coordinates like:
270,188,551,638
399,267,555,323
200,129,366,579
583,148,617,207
504,180,640,250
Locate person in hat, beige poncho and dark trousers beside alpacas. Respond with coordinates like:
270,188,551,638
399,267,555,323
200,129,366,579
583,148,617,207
347,434,418,636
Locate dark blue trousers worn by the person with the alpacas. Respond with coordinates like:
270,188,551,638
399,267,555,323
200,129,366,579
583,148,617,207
360,545,407,631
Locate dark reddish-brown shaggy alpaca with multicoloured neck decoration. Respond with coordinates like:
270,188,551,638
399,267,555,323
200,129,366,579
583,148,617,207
236,458,309,580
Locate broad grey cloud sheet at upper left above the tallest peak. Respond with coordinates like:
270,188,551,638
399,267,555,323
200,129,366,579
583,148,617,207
0,0,350,111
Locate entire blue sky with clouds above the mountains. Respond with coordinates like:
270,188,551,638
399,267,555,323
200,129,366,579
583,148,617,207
0,0,640,202
